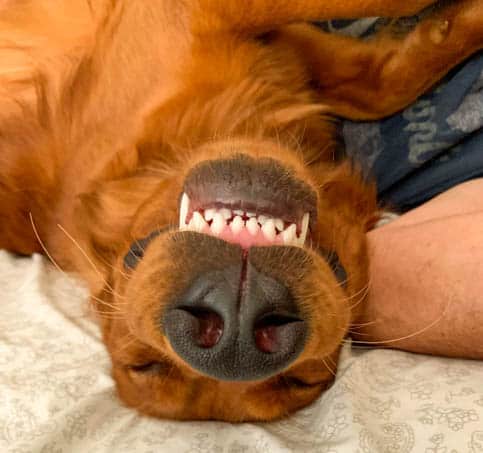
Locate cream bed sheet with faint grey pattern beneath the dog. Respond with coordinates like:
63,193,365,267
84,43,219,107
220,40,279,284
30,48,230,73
0,252,483,453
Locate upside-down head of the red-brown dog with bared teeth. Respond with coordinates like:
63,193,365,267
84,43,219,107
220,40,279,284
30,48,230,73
91,134,375,421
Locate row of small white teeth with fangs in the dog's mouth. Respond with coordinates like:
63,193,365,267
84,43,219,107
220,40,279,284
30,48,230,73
180,194,310,246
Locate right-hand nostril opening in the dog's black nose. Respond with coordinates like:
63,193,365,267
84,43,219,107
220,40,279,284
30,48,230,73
254,314,301,354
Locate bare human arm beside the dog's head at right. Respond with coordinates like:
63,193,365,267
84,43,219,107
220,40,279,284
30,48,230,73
353,179,483,359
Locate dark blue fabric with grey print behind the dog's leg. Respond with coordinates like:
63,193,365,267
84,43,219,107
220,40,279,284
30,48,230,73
322,19,483,211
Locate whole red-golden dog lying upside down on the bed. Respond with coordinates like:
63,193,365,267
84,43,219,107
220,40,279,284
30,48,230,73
0,0,483,422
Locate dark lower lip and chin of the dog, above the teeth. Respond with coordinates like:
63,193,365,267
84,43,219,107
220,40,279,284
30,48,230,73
183,154,317,230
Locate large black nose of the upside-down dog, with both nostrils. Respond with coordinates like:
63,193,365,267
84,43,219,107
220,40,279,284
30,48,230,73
162,260,306,381
